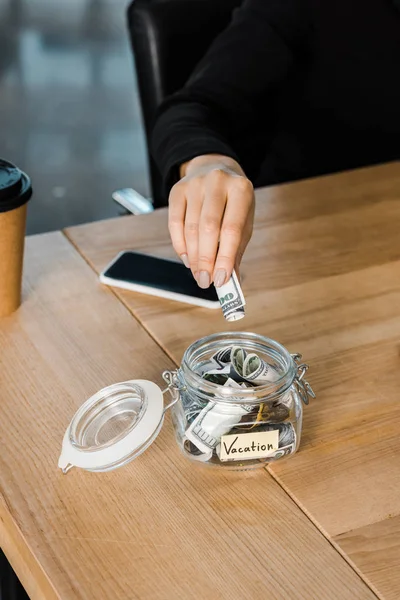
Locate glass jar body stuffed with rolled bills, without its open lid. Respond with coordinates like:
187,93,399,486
171,333,313,469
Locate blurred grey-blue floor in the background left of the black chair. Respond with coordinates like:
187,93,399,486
0,0,149,233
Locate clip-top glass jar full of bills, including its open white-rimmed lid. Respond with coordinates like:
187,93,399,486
58,333,315,473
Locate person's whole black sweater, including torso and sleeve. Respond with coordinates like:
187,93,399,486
152,0,400,191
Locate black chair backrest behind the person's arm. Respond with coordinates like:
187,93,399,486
128,0,242,208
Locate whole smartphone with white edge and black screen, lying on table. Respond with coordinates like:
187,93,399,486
100,251,221,308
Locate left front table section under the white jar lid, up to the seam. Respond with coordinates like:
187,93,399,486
0,234,376,600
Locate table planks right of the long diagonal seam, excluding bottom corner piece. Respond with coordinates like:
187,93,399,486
67,163,400,596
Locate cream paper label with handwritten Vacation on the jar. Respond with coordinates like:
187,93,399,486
220,429,279,461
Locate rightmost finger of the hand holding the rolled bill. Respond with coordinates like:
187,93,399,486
214,178,254,287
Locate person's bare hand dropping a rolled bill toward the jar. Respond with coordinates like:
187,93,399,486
168,154,254,288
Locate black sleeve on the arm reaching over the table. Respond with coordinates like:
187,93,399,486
151,0,308,192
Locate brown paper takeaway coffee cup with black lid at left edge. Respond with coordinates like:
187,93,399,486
0,159,32,317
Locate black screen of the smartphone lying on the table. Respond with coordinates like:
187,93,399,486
104,252,218,302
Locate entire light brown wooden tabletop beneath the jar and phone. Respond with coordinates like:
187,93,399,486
0,164,400,600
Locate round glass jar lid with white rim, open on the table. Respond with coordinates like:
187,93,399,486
58,379,164,473
